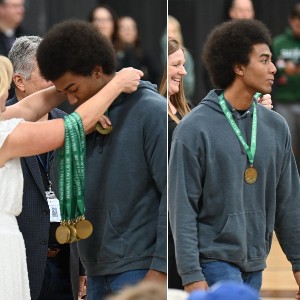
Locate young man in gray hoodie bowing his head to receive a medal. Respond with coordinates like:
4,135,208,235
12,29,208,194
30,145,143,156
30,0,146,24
37,21,167,300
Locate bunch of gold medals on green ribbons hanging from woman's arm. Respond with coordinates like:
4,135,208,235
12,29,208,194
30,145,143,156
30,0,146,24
55,112,93,244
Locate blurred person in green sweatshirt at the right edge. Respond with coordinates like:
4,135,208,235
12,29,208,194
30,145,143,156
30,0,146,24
272,2,300,175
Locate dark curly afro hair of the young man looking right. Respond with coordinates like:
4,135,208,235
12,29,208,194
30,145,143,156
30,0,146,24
202,20,271,89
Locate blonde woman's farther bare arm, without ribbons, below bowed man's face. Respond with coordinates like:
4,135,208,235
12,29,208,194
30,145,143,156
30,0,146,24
2,86,66,121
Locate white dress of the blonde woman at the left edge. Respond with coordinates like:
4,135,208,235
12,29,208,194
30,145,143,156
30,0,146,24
0,119,30,300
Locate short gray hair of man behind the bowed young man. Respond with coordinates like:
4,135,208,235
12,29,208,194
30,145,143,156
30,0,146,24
8,36,42,80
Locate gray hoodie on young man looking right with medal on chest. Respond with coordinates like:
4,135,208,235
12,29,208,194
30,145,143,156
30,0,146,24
169,90,300,285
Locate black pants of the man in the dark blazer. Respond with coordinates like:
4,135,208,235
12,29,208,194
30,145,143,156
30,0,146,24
38,244,73,300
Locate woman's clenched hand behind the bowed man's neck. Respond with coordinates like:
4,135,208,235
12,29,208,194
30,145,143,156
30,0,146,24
114,67,144,93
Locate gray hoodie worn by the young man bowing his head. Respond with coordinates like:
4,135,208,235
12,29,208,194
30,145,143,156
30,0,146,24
78,81,167,276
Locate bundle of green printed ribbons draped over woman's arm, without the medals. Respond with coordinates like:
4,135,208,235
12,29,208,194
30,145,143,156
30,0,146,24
59,112,86,223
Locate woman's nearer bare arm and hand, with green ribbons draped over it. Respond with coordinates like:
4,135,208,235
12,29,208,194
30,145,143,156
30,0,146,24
0,68,143,167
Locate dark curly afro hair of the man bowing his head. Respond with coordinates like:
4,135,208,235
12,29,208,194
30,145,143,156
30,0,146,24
37,20,116,81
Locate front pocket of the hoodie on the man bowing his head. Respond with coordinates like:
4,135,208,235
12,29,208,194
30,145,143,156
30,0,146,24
79,209,125,262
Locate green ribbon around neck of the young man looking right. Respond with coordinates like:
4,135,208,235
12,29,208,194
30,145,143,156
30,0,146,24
219,93,257,167
